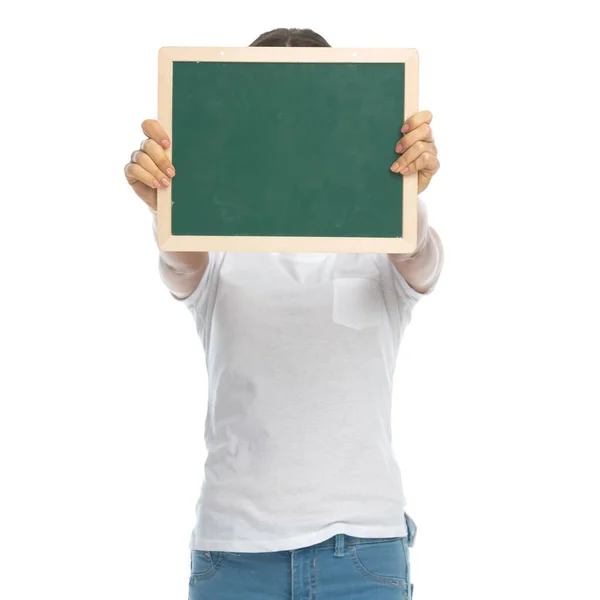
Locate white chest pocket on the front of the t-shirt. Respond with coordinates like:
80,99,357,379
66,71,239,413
332,277,383,330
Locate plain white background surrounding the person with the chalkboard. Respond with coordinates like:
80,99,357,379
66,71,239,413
0,0,600,600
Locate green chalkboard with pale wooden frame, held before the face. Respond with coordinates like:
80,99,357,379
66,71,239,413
158,47,417,252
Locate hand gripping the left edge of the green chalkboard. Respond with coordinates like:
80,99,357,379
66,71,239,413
125,119,175,212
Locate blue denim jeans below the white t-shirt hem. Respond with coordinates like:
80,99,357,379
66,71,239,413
188,515,417,600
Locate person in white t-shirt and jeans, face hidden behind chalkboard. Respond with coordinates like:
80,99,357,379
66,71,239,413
125,29,443,600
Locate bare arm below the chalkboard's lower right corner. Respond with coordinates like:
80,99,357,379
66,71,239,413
388,198,444,293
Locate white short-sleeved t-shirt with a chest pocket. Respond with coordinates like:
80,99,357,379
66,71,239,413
176,253,431,552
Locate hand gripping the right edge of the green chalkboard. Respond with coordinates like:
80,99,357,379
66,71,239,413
390,110,440,194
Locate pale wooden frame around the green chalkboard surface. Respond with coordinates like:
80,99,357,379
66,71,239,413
157,46,419,254
